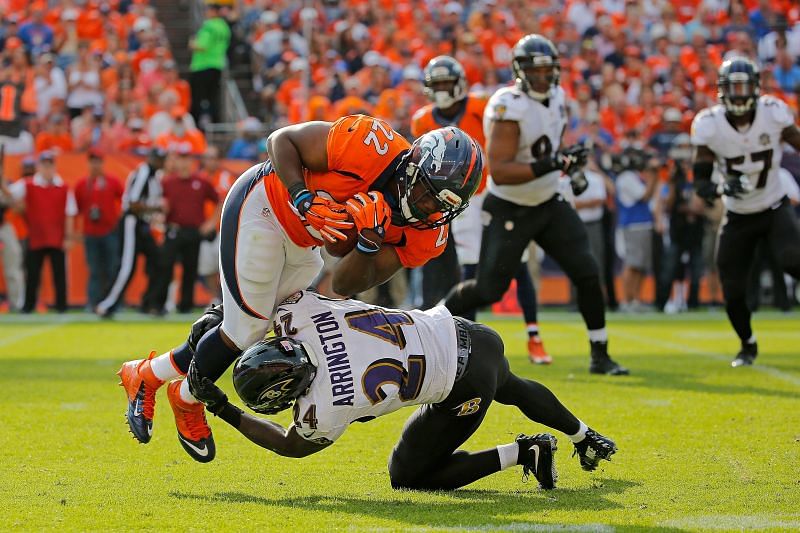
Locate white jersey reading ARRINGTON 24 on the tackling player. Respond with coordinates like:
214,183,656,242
275,291,458,443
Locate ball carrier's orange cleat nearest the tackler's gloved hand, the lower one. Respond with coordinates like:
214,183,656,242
167,378,217,463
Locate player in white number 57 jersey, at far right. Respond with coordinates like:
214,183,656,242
692,58,800,367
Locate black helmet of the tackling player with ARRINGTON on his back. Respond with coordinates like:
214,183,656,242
233,337,317,415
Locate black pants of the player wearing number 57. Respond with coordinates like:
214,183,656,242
717,198,800,342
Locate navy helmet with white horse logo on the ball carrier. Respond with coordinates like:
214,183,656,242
398,126,483,228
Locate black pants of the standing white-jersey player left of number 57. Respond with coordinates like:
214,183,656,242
445,194,606,330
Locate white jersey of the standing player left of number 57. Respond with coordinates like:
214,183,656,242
483,87,567,205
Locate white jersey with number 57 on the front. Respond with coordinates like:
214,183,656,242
692,95,794,214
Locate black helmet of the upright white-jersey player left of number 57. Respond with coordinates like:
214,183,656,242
511,33,561,102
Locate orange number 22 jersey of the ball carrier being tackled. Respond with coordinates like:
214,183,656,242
264,115,448,268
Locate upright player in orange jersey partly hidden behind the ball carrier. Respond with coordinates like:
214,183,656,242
411,56,553,364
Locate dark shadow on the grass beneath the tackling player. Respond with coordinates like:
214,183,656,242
170,479,644,531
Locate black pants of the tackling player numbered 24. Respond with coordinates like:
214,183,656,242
389,319,580,490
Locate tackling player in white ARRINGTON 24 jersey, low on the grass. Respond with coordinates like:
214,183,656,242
188,291,617,490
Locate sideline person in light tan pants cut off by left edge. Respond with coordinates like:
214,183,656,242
0,154,27,311
